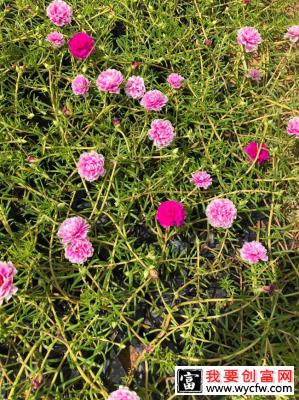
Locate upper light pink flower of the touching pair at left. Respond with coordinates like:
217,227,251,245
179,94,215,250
57,217,90,245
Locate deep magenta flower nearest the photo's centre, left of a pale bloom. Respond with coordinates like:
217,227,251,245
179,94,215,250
156,200,186,228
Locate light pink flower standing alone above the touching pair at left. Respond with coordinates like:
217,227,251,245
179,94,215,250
77,150,106,182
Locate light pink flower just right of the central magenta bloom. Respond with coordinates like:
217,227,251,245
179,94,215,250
206,199,237,229
